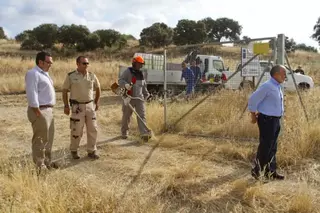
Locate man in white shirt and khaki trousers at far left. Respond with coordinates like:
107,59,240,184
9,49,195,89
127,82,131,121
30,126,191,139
25,52,56,169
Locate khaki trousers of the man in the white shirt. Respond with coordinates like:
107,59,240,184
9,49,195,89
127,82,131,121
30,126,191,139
27,107,55,166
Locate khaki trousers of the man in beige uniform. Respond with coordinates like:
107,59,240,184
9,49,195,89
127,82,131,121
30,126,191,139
70,102,98,153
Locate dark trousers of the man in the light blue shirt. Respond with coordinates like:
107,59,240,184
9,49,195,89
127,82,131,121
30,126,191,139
254,113,280,174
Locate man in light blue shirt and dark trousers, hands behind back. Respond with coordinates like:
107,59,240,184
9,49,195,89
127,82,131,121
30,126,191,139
248,65,286,180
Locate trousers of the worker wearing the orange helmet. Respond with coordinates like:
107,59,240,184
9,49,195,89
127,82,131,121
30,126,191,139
121,100,151,136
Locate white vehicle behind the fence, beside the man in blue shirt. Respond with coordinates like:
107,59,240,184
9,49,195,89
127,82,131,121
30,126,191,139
224,60,314,91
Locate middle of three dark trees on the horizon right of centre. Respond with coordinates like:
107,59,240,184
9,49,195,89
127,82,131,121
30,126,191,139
173,19,207,45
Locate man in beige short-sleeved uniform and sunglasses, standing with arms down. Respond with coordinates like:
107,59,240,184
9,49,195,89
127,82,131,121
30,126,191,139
62,56,101,159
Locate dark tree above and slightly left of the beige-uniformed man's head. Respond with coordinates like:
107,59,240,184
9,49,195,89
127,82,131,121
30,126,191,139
58,24,90,47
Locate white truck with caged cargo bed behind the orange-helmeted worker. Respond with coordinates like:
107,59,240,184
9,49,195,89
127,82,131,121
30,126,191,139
119,53,226,95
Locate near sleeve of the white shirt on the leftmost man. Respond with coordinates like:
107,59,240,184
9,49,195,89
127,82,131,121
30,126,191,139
25,71,39,108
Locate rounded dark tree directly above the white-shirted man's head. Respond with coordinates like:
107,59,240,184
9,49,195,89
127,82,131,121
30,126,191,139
32,24,59,48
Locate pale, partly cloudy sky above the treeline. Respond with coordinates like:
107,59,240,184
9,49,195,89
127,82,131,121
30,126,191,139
0,0,320,48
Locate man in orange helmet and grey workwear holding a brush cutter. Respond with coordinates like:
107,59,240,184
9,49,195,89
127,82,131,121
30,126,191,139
118,56,151,141
